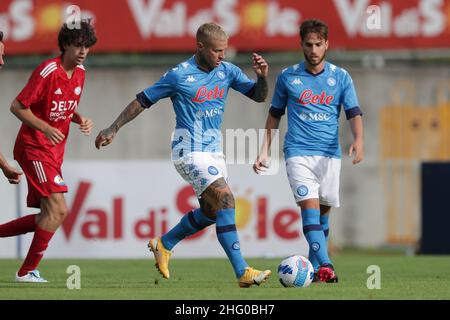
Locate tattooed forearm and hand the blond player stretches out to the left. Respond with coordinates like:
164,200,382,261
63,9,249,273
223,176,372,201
95,99,144,149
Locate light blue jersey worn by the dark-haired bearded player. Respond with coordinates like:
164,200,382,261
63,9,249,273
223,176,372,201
270,62,361,159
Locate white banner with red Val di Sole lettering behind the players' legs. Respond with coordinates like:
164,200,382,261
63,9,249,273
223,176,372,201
14,161,308,258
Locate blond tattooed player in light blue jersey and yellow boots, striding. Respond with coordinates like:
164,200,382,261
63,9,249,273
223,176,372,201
95,23,271,287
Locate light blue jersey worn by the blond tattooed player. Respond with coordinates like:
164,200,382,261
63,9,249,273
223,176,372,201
138,56,255,157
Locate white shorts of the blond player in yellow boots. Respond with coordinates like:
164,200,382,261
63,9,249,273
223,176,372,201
173,152,228,198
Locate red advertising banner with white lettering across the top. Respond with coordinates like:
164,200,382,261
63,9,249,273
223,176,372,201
0,0,450,54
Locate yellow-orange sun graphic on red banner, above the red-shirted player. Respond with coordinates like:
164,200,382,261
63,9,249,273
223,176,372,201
35,3,63,37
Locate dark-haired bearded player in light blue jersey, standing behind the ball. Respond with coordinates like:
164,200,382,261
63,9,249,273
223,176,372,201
253,20,364,283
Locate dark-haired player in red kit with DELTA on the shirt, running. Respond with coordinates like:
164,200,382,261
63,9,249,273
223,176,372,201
0,21,97,282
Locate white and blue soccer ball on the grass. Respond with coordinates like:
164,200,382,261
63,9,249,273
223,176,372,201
278,255,314,288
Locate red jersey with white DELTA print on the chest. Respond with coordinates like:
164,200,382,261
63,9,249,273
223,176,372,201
14,57,85,166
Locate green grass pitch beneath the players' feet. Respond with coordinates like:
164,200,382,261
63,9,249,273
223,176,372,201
0,252,450,300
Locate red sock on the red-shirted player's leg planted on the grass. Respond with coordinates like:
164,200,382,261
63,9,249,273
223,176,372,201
18,225,55,277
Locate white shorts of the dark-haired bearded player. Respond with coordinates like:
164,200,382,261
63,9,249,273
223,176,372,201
286,156,341,207
